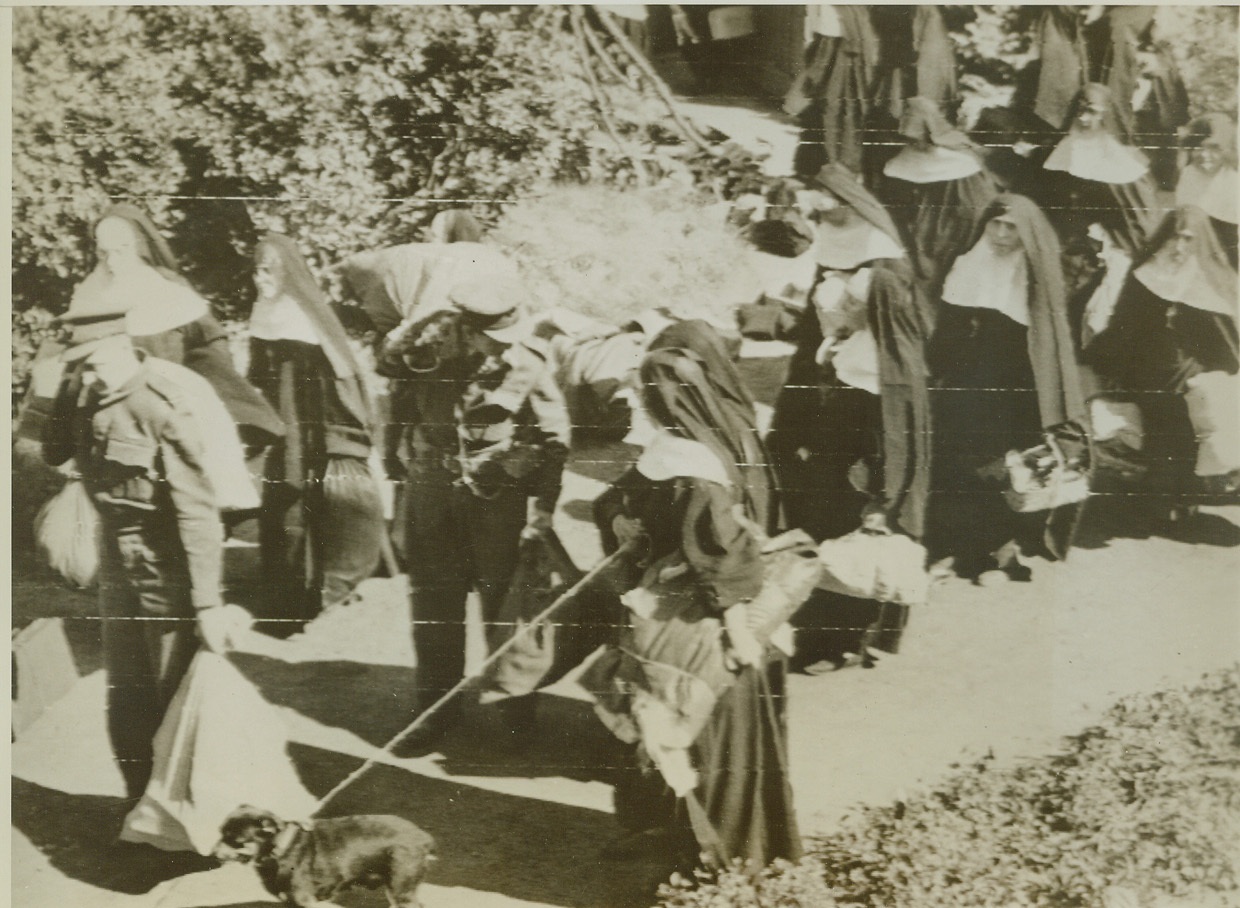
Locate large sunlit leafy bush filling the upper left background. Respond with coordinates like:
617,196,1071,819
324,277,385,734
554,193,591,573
14,6,631,314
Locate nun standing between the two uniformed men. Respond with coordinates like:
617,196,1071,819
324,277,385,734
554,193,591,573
249,233,386,620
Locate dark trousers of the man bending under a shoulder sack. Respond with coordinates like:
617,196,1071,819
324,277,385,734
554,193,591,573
405,463,527,708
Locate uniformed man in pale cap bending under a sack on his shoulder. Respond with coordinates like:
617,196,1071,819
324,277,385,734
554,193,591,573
381,274,569,753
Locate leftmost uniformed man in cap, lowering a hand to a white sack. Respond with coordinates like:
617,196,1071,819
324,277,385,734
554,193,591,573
43,300,234,798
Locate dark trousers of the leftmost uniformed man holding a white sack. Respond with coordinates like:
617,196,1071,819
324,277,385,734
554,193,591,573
99,527,198,798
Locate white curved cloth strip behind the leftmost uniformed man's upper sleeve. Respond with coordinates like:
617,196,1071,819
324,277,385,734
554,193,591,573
146,356,259,511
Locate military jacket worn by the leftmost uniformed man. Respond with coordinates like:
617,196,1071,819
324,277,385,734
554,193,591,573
43,363,223,610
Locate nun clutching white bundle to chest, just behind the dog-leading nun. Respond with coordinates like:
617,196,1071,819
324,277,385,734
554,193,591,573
768,165,931,665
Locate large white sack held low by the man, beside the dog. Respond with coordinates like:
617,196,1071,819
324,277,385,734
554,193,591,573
120,650,316,855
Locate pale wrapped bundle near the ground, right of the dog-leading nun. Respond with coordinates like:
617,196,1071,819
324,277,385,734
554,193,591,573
818,530,930,605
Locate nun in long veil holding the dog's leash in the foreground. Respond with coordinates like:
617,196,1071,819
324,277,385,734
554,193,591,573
590,321,801,873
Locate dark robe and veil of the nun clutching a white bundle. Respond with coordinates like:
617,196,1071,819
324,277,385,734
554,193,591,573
768,259,930,664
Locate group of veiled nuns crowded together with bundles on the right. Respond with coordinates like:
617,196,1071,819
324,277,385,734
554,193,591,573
740,7,1240,625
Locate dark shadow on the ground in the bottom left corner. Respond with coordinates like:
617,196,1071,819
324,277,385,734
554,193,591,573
12,778,217,894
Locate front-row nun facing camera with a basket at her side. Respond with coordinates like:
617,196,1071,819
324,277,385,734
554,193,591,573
926,194,1085,583
